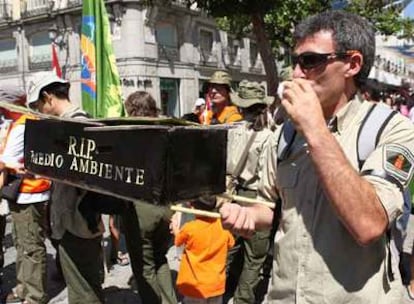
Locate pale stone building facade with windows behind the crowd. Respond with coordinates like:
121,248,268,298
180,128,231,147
0,0,265,117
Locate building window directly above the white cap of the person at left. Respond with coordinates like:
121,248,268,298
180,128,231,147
30,32,52,69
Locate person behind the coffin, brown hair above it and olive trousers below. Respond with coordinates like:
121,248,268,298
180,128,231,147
122,91,178,304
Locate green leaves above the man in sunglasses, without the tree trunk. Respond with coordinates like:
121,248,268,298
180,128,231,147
210,0,414,55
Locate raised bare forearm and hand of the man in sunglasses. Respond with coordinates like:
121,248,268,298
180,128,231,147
282,79,406,245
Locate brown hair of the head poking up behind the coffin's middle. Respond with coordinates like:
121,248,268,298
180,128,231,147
125,91,159,117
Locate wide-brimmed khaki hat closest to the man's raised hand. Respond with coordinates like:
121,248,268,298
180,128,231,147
230,80,275,108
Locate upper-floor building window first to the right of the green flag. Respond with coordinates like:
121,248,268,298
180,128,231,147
155,23,179,60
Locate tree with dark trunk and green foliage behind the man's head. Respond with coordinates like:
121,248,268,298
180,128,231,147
151,0,414,94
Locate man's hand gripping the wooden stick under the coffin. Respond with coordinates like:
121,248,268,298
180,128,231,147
219,203,256,238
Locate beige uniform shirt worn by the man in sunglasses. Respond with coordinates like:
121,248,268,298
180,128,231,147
258,96,414,304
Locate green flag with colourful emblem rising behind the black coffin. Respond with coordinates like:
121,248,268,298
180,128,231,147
81,0,124,118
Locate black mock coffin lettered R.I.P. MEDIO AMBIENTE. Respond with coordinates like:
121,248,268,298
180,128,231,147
24,119,227,204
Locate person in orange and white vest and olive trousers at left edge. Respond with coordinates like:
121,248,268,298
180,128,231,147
0,86,51,304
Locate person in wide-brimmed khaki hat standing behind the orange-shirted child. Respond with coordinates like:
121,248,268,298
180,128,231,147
222,80,274,303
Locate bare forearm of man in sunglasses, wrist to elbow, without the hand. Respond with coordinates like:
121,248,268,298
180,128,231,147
307,123,388,245
